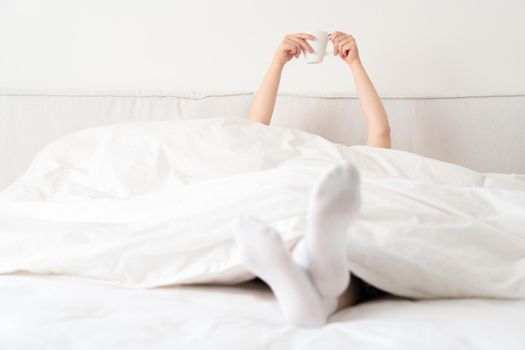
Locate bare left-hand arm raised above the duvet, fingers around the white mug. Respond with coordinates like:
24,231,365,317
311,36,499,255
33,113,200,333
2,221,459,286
248,33,314,125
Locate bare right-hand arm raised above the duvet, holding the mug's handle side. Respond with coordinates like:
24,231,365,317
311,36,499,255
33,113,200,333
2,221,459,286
331,32,391,148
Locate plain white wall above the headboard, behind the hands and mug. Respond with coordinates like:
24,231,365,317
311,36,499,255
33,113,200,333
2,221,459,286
0,0,525,97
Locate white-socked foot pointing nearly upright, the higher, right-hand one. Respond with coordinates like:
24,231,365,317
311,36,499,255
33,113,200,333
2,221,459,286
292,162,361,299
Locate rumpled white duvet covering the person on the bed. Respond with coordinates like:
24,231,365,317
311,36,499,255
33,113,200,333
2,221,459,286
0,118,525,298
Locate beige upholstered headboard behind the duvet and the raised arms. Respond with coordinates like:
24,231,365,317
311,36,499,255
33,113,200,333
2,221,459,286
0,90,525,189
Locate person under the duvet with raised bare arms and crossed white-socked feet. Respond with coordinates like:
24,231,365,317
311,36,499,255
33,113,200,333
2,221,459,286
233,32,391,327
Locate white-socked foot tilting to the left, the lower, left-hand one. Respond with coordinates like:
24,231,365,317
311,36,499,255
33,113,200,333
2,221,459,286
233,217,326,327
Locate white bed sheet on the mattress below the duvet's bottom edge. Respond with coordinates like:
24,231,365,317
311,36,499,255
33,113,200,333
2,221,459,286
0,275,525,350
